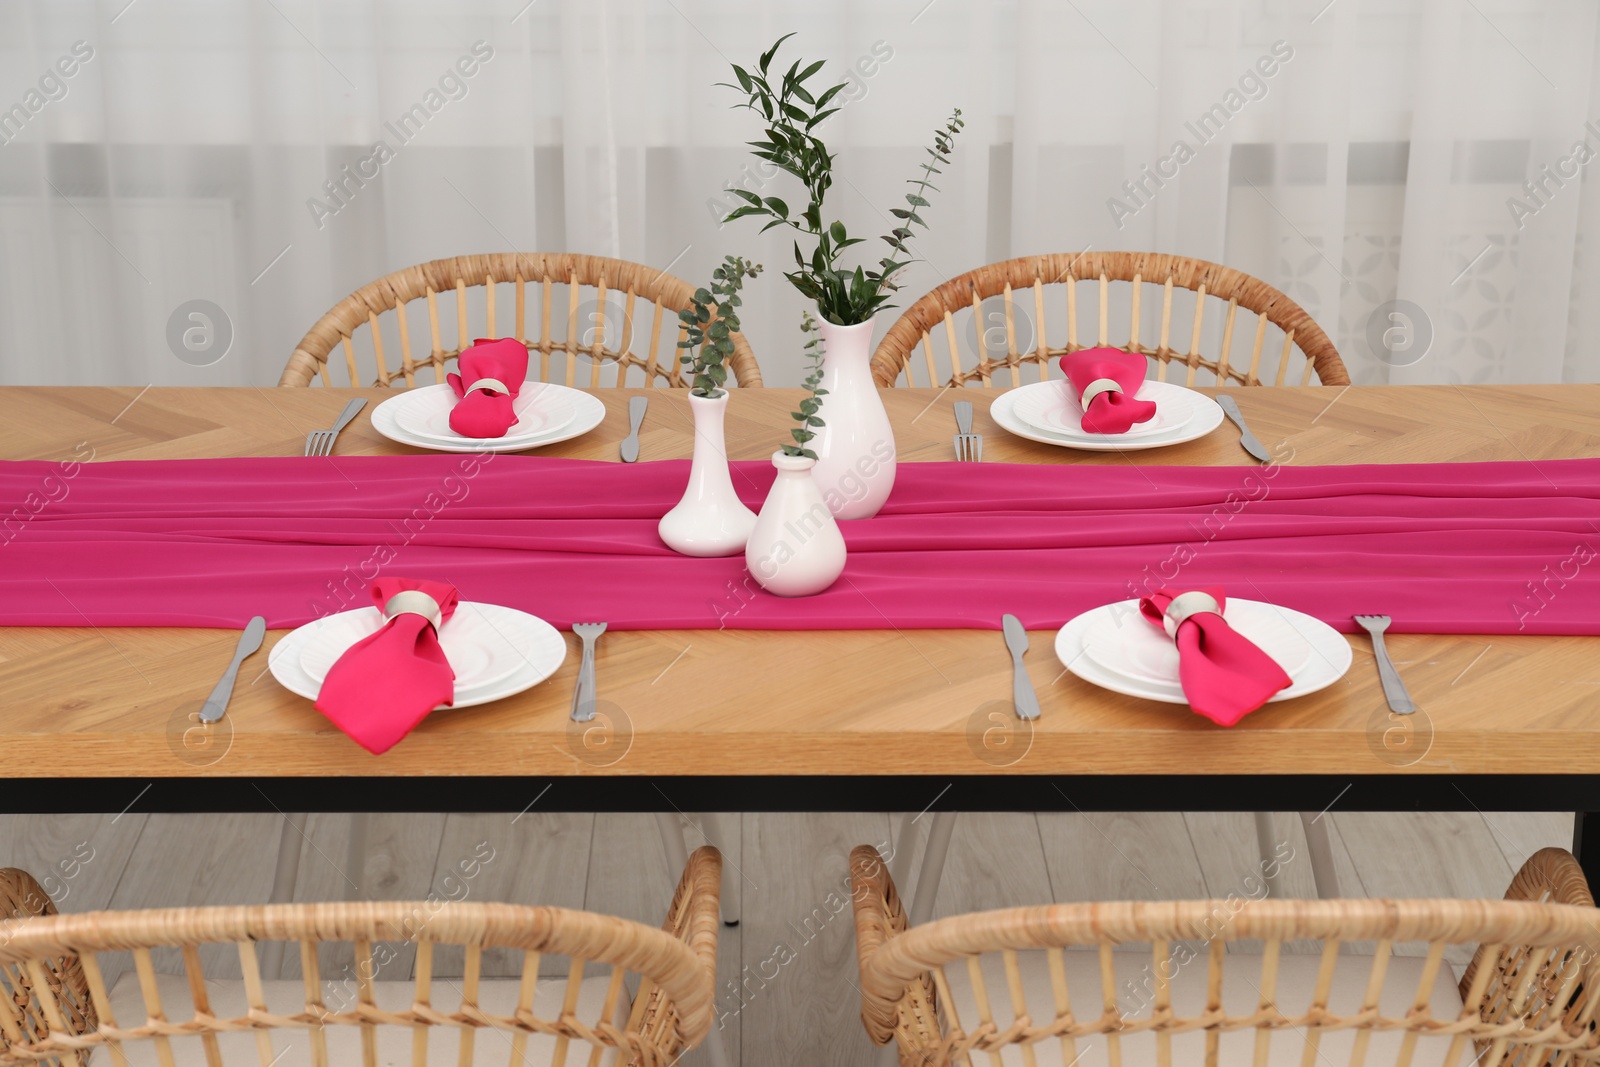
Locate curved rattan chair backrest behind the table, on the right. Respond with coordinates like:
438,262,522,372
872,251,1350,387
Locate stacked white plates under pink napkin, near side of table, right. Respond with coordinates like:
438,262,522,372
1056,598,1354,704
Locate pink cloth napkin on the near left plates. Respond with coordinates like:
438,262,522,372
317,577,456,755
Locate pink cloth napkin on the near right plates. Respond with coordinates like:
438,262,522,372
1139,587,1293,726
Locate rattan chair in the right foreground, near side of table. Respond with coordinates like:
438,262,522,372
850,846,1600,1067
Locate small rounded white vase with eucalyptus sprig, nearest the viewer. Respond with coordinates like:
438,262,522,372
744,451,845,597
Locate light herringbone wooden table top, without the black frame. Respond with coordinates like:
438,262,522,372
0,386,1600,780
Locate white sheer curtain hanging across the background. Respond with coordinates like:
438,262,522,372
0,0,1600,386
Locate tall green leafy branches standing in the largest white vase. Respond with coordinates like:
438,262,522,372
718,34,966,326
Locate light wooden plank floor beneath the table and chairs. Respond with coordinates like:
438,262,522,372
0,811,1571,1067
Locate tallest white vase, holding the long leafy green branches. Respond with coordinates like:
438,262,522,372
808,322,894,518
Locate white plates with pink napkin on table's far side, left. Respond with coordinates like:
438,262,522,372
373,338,605,453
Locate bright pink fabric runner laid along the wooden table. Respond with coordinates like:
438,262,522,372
0,456,1600,633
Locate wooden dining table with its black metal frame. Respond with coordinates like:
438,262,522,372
0,384,1600,883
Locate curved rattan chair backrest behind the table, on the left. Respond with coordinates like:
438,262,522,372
278,253,762,389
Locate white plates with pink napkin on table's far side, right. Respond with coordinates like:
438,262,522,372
989,347,1224,453
